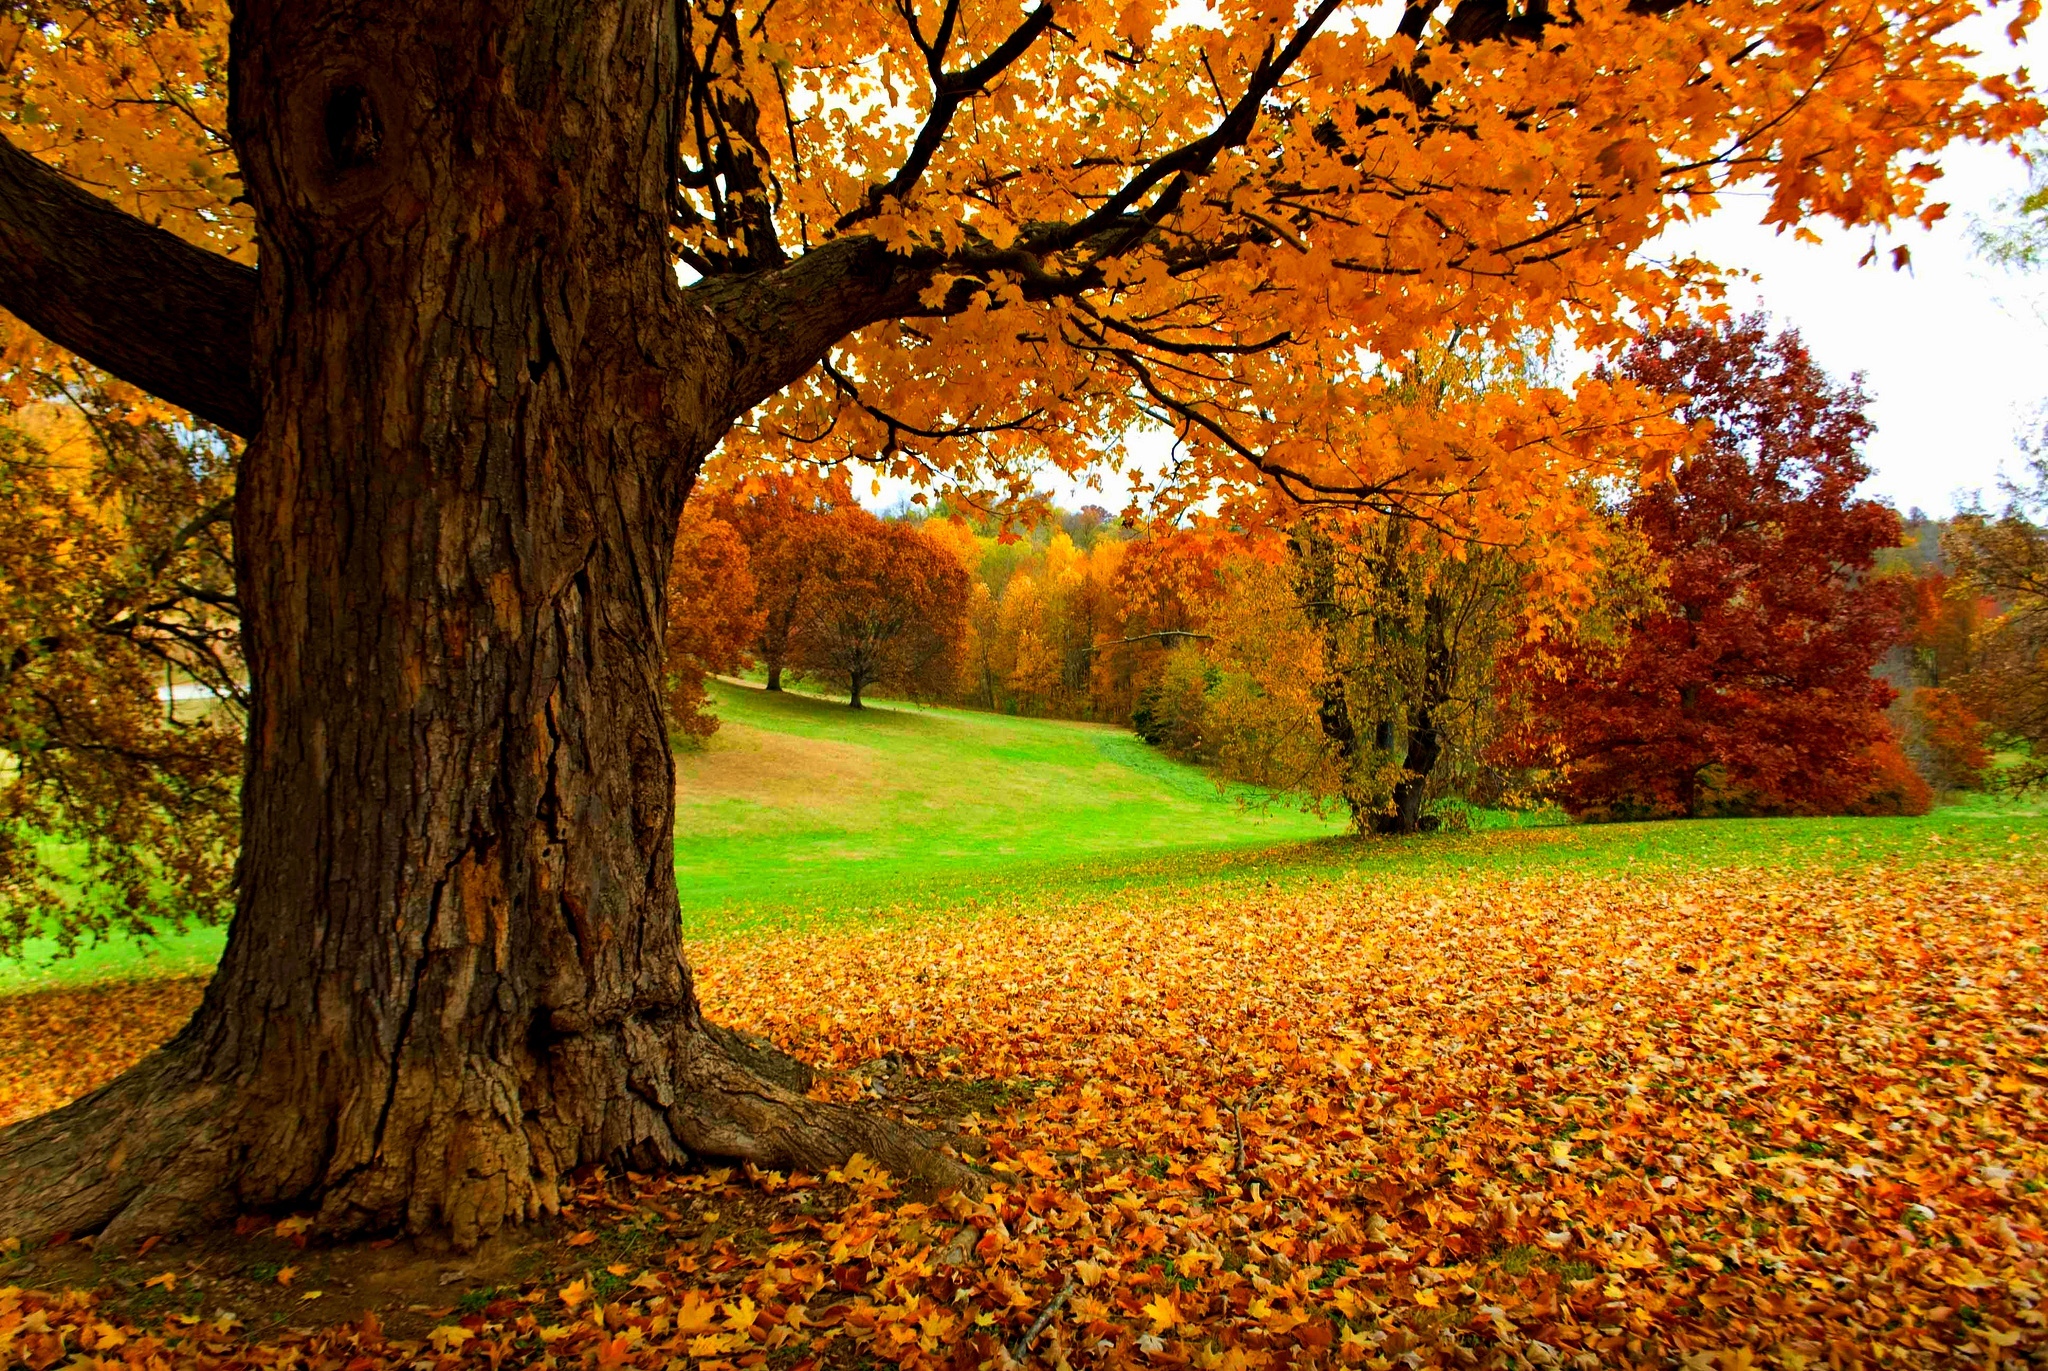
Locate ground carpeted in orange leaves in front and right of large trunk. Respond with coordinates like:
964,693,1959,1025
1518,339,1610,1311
0,844,2048,1371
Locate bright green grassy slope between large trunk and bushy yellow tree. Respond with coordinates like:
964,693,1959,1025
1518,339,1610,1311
676,682,1341,930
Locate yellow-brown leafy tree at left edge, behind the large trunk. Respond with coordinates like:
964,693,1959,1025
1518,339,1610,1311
0,377,242,953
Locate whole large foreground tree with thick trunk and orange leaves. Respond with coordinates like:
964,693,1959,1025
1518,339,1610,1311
0,0,2040,1244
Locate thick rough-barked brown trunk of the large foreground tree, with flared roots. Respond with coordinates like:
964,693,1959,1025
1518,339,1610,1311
0,0,969,1244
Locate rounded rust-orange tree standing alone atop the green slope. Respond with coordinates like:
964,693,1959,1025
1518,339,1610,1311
791,506,969,709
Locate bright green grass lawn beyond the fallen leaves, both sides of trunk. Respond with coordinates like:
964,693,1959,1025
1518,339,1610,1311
0,682,2048,994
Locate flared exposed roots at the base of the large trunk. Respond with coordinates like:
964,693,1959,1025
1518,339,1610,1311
0,1014,981,1248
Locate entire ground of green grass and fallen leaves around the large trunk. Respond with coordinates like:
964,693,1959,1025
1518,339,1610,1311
0,687,2048,1371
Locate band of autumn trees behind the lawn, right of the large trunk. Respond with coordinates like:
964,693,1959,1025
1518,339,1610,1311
670,318,2048,832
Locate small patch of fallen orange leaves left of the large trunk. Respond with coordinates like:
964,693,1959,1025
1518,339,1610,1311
0,978,207,1125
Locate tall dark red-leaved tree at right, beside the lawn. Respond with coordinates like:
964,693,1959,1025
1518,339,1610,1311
1522,316,1898,818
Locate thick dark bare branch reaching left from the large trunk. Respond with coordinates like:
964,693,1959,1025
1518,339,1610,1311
0,137,258,437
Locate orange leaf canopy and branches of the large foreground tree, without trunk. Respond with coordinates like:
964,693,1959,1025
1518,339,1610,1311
0,0,2040,533
